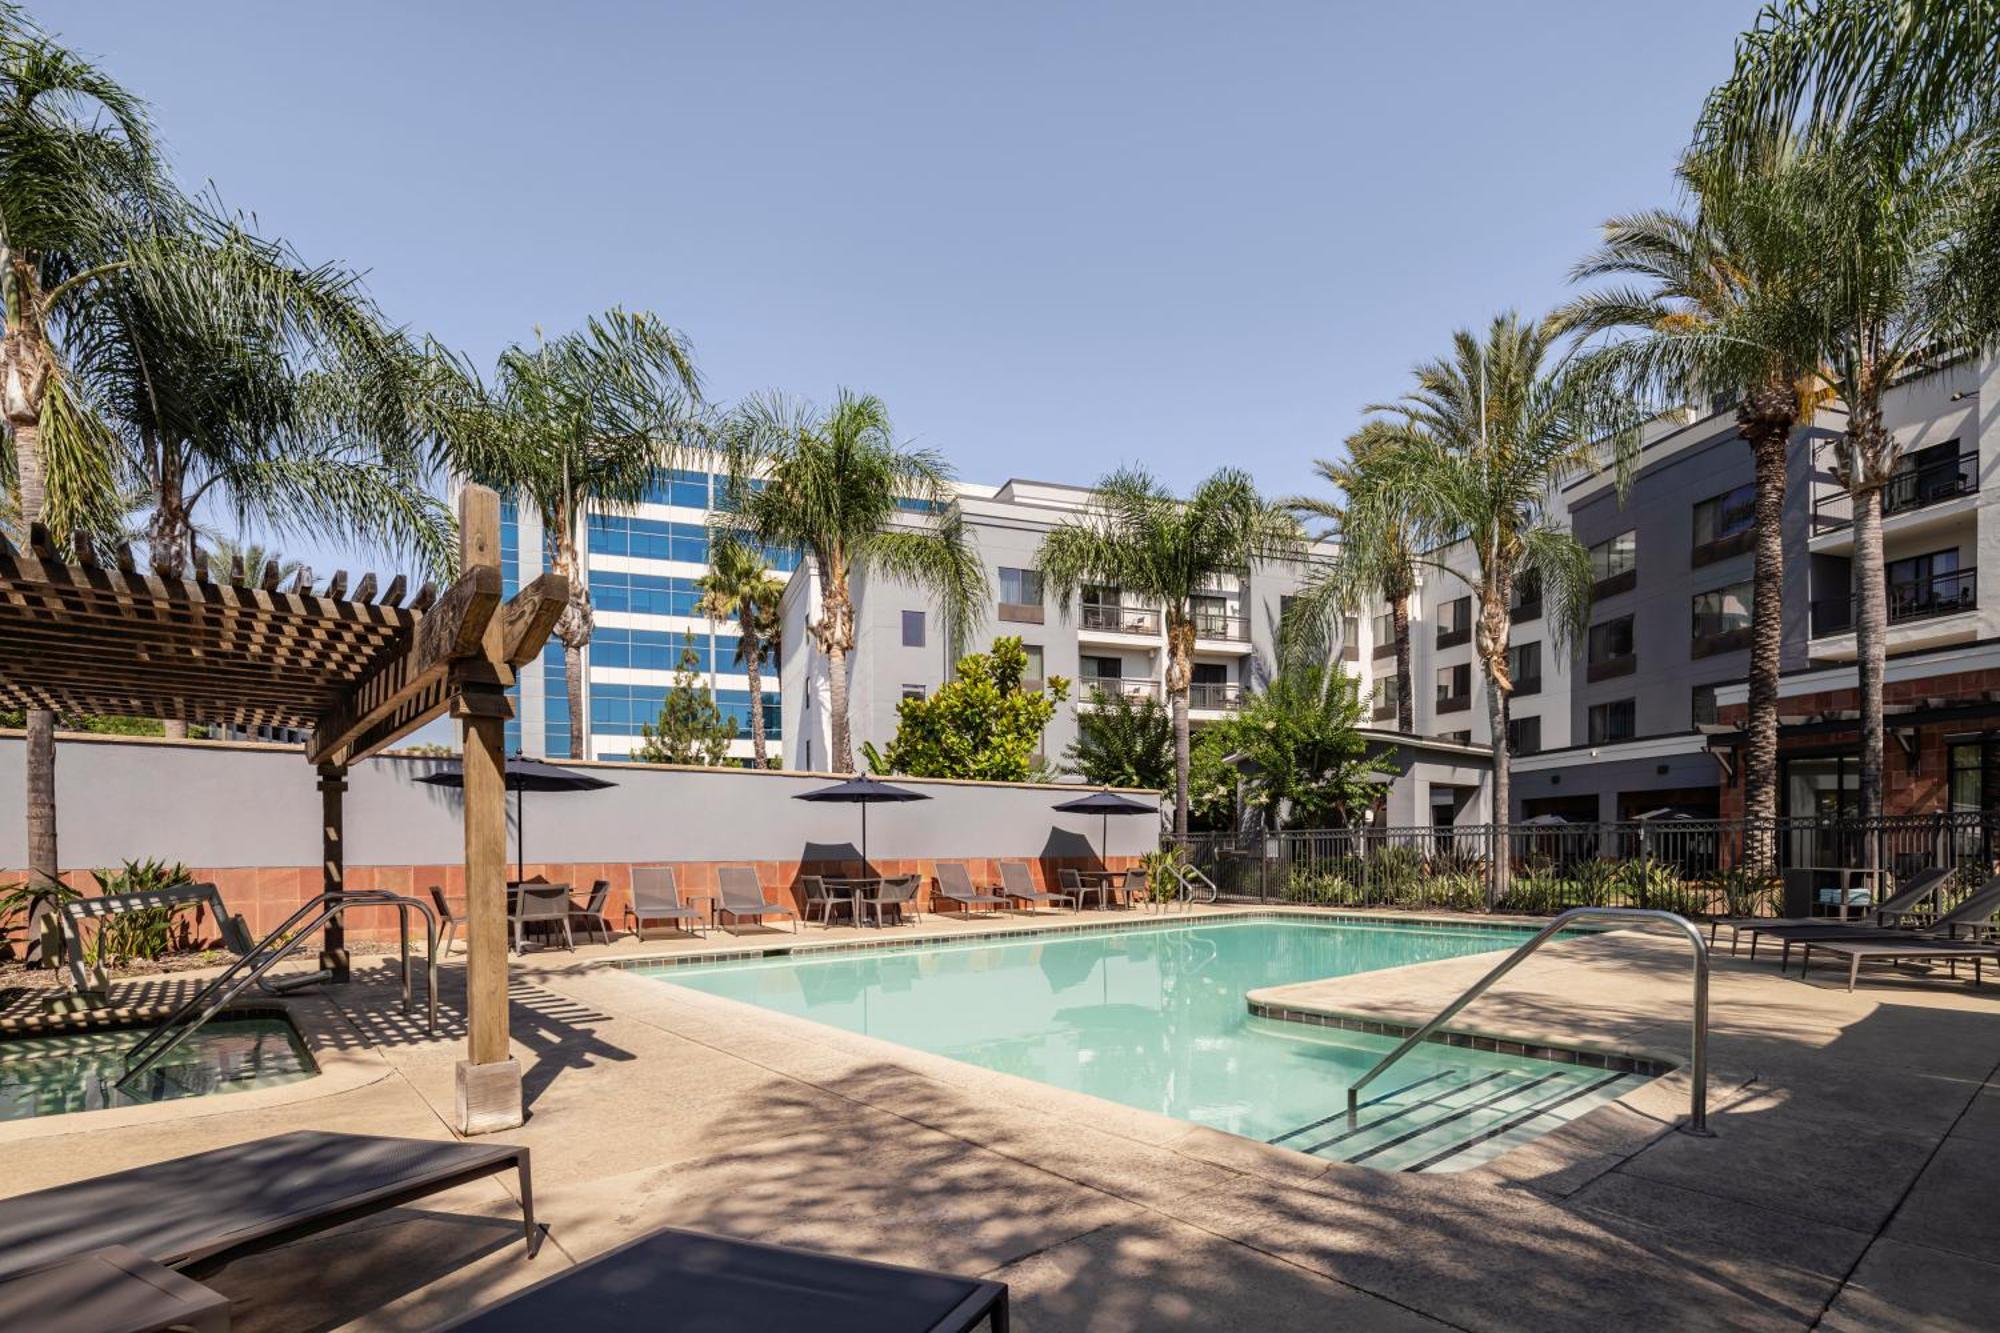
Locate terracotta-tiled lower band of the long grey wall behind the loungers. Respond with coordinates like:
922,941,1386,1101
0,857,1138,947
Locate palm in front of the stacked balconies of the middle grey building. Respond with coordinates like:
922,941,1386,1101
1036,468,1306,837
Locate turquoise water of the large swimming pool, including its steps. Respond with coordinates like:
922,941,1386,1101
644,921,1646,1171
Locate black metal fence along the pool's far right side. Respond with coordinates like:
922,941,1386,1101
1182,813,2000,915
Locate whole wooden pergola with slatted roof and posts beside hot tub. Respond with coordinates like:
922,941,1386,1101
0,486,568,1133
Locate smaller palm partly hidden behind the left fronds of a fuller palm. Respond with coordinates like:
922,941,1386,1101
1282,426,1416,733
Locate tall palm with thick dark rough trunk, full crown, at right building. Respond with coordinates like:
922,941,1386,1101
1554,152,1826,865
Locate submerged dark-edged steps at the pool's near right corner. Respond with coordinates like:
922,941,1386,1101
1270,1063,1644,1171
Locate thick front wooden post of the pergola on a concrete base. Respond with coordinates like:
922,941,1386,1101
452,486,524,1135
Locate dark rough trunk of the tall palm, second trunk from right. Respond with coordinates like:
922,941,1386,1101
1744,404,1792,875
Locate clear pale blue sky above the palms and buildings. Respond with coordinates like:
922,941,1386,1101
54,0,1756,562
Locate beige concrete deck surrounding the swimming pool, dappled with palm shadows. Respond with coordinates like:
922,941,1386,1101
0,911,2000,1331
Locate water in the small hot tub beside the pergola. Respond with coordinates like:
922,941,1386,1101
0,1019,318,1121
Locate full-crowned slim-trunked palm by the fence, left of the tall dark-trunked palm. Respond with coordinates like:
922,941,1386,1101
1350,312,1638,880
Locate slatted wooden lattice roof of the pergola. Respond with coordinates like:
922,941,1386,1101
0,526,436,731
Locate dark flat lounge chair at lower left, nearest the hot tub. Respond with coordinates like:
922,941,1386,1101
0,1129,536,1281
